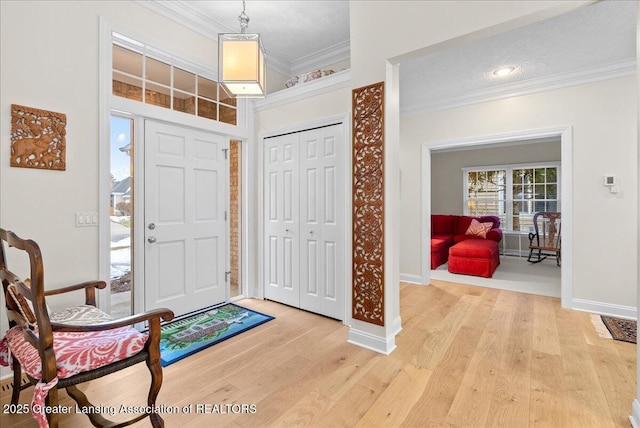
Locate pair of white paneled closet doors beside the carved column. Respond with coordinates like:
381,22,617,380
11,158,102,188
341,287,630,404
263,124,346,320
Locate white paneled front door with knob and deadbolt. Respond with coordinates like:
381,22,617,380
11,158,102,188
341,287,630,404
144,120,229,315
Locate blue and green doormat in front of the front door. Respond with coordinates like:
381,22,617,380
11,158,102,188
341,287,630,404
160,303,274,367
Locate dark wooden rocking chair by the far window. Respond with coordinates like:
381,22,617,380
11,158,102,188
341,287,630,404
527,212,562,266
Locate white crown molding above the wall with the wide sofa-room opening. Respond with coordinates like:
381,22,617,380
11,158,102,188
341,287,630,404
400,59,636,116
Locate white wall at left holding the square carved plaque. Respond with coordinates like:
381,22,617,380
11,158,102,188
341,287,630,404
0,1,217,374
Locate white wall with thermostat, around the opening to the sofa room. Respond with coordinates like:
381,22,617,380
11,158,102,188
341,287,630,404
400,77,638,307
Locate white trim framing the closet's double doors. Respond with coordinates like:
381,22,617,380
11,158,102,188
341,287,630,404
254,114,352,325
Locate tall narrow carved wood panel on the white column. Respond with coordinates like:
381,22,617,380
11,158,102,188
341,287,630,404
351,82,384,326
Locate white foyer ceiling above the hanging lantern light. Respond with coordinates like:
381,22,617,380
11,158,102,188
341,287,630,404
140,0,350,76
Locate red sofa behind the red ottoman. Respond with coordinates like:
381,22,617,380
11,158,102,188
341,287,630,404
431,214,502,269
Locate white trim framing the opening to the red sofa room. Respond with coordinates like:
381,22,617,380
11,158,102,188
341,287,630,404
421,125,577,309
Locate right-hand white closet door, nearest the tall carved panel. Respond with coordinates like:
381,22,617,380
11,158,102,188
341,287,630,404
300,125,345,319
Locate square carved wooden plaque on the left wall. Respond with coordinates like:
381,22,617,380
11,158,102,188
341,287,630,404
11,104,67,171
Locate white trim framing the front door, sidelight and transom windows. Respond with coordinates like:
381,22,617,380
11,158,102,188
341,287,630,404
98,16,254,313
